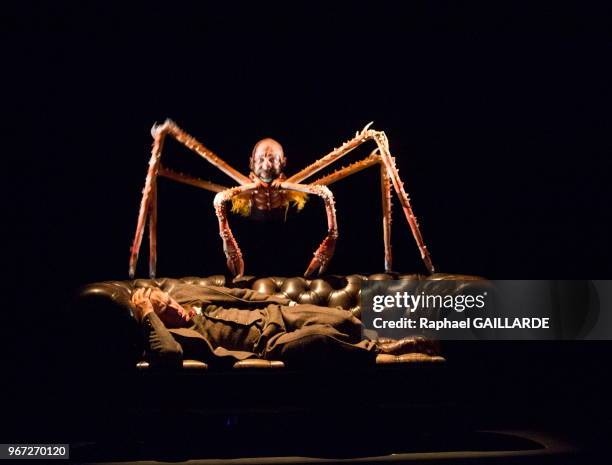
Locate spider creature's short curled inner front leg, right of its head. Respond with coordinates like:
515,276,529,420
278,182,338,276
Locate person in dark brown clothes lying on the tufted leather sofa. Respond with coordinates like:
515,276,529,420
131,284,437,368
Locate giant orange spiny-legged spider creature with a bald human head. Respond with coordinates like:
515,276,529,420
129,119,434,278
